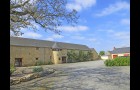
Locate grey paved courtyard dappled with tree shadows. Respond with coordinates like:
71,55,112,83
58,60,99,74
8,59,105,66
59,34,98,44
10,60,130,90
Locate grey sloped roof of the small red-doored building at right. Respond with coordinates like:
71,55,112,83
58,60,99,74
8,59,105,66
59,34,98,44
109,47,130,54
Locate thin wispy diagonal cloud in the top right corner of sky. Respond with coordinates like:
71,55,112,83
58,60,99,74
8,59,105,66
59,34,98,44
95,2,130,17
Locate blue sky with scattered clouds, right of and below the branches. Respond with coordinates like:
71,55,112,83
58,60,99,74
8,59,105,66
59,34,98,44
20,0,130,52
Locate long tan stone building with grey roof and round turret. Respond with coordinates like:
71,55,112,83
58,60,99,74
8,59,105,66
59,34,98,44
10,37,98,66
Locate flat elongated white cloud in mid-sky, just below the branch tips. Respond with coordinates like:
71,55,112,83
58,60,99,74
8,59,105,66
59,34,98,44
58,26,88,32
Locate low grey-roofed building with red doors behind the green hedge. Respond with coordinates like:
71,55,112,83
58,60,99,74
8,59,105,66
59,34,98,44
108,47,130,59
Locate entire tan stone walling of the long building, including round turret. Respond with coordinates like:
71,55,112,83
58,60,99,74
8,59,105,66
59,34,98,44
10,46,98,66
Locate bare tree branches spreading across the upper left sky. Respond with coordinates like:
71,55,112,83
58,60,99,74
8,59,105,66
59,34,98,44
10,0,79,36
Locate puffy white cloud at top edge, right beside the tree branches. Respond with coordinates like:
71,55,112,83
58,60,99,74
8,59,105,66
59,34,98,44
66,0,96,11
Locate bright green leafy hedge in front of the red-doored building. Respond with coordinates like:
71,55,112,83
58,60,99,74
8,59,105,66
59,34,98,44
104,57,130,66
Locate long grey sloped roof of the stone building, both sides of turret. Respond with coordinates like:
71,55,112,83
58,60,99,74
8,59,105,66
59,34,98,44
10,37,90,50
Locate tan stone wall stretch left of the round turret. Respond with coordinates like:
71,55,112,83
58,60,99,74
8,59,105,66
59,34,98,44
10,46,52,66
